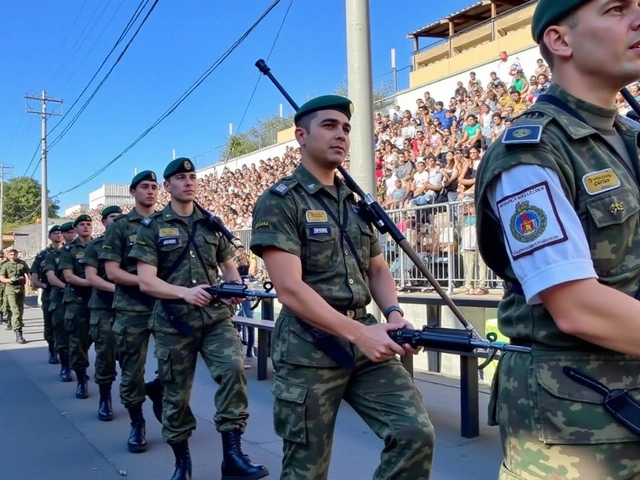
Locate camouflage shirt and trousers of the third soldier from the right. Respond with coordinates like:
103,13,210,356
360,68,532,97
129,205,249,445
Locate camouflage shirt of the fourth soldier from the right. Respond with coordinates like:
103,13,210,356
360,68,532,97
98,209,155,313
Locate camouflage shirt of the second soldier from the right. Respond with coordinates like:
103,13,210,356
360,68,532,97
251,165,382,310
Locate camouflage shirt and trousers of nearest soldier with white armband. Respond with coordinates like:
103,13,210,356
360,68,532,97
476,86,640,480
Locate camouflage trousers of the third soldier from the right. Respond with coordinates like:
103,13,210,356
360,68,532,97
153,309,249,445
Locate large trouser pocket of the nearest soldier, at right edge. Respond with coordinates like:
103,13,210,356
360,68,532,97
533,355,640,445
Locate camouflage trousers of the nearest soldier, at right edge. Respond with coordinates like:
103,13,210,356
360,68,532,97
489,352,640,480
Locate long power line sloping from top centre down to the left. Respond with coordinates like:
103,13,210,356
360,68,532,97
51,0,281,198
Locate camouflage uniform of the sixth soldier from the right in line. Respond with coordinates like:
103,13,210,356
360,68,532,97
58,237,92,398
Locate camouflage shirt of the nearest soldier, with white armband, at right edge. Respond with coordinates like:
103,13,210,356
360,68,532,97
475,85,640,350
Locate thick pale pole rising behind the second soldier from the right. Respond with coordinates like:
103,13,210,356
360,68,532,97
346,0,380,319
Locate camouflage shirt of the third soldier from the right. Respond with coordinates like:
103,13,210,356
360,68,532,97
129,204,234,319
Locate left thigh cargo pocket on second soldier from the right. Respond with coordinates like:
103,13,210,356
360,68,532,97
271,377,308,444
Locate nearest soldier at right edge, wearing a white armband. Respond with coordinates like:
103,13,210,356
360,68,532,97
475,0,640,480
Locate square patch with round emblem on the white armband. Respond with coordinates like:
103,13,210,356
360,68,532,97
497,182,568,260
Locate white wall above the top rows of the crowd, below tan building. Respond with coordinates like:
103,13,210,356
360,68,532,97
396,46,540,113
